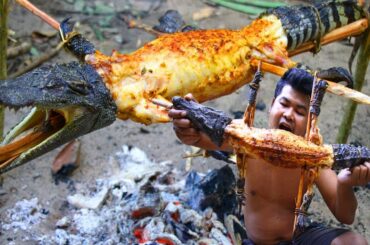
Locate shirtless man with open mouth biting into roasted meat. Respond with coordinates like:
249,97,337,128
169,69,370,245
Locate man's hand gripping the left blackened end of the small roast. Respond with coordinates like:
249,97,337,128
168,94,201,145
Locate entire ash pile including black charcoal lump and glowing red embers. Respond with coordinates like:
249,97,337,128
0,146,246,245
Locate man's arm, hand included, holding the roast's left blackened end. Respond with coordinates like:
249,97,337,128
168,94,233,152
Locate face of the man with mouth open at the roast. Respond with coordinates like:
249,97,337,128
269,85,310,136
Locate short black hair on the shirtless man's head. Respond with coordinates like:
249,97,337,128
274,68,313,98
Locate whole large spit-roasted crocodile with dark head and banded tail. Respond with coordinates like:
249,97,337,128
0,1,367,173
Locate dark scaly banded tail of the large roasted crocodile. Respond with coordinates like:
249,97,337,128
263,0,366,51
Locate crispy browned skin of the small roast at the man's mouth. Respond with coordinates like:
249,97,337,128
225,120,334,168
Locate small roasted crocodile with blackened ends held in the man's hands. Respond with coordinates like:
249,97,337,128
173,97,370,169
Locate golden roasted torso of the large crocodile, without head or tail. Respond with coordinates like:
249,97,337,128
85,15,294,124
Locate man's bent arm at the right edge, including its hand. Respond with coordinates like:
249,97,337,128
316,162,370,224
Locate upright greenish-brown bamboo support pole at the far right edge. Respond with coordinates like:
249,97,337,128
336,25,370,143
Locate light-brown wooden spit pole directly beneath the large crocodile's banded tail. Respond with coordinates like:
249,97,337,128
289,18,369,56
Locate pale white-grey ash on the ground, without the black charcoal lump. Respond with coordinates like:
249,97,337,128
3,146,236,245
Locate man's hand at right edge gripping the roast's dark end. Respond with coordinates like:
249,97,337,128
338,162,370,186
